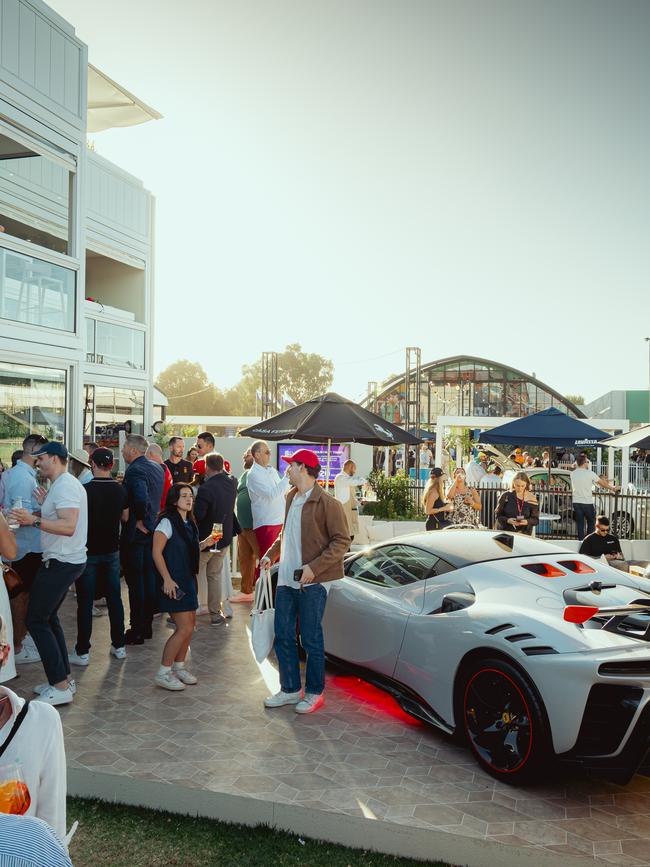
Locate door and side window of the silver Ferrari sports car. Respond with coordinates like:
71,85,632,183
323,544,438,676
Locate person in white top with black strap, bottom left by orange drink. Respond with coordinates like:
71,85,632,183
0,617,66,836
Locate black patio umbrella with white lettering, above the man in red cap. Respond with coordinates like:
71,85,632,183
240,391,421,480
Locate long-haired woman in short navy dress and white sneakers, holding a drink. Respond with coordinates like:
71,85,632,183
153,483,212,690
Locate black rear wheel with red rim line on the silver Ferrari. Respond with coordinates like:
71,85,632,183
456,659,553,784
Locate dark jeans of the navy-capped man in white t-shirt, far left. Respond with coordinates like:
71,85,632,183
25,560,85,686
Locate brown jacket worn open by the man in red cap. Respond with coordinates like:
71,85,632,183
266,485,352,584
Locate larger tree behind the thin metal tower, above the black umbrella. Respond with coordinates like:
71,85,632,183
226,343,334,415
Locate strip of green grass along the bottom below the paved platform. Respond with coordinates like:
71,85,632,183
68,798,444,867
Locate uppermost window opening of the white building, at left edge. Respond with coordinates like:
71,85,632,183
0,131,72,254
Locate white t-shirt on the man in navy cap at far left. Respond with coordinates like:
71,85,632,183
41,473,88,563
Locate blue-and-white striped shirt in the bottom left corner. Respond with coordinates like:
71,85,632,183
0,813,72,867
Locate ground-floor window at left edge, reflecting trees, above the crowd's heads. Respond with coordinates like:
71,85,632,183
0,361,66,466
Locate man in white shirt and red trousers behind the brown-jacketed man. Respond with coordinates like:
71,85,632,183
246,440,289,576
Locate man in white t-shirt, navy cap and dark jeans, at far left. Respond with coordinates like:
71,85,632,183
13,442,88,705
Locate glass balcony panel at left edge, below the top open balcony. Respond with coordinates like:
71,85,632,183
0,251,76,331
